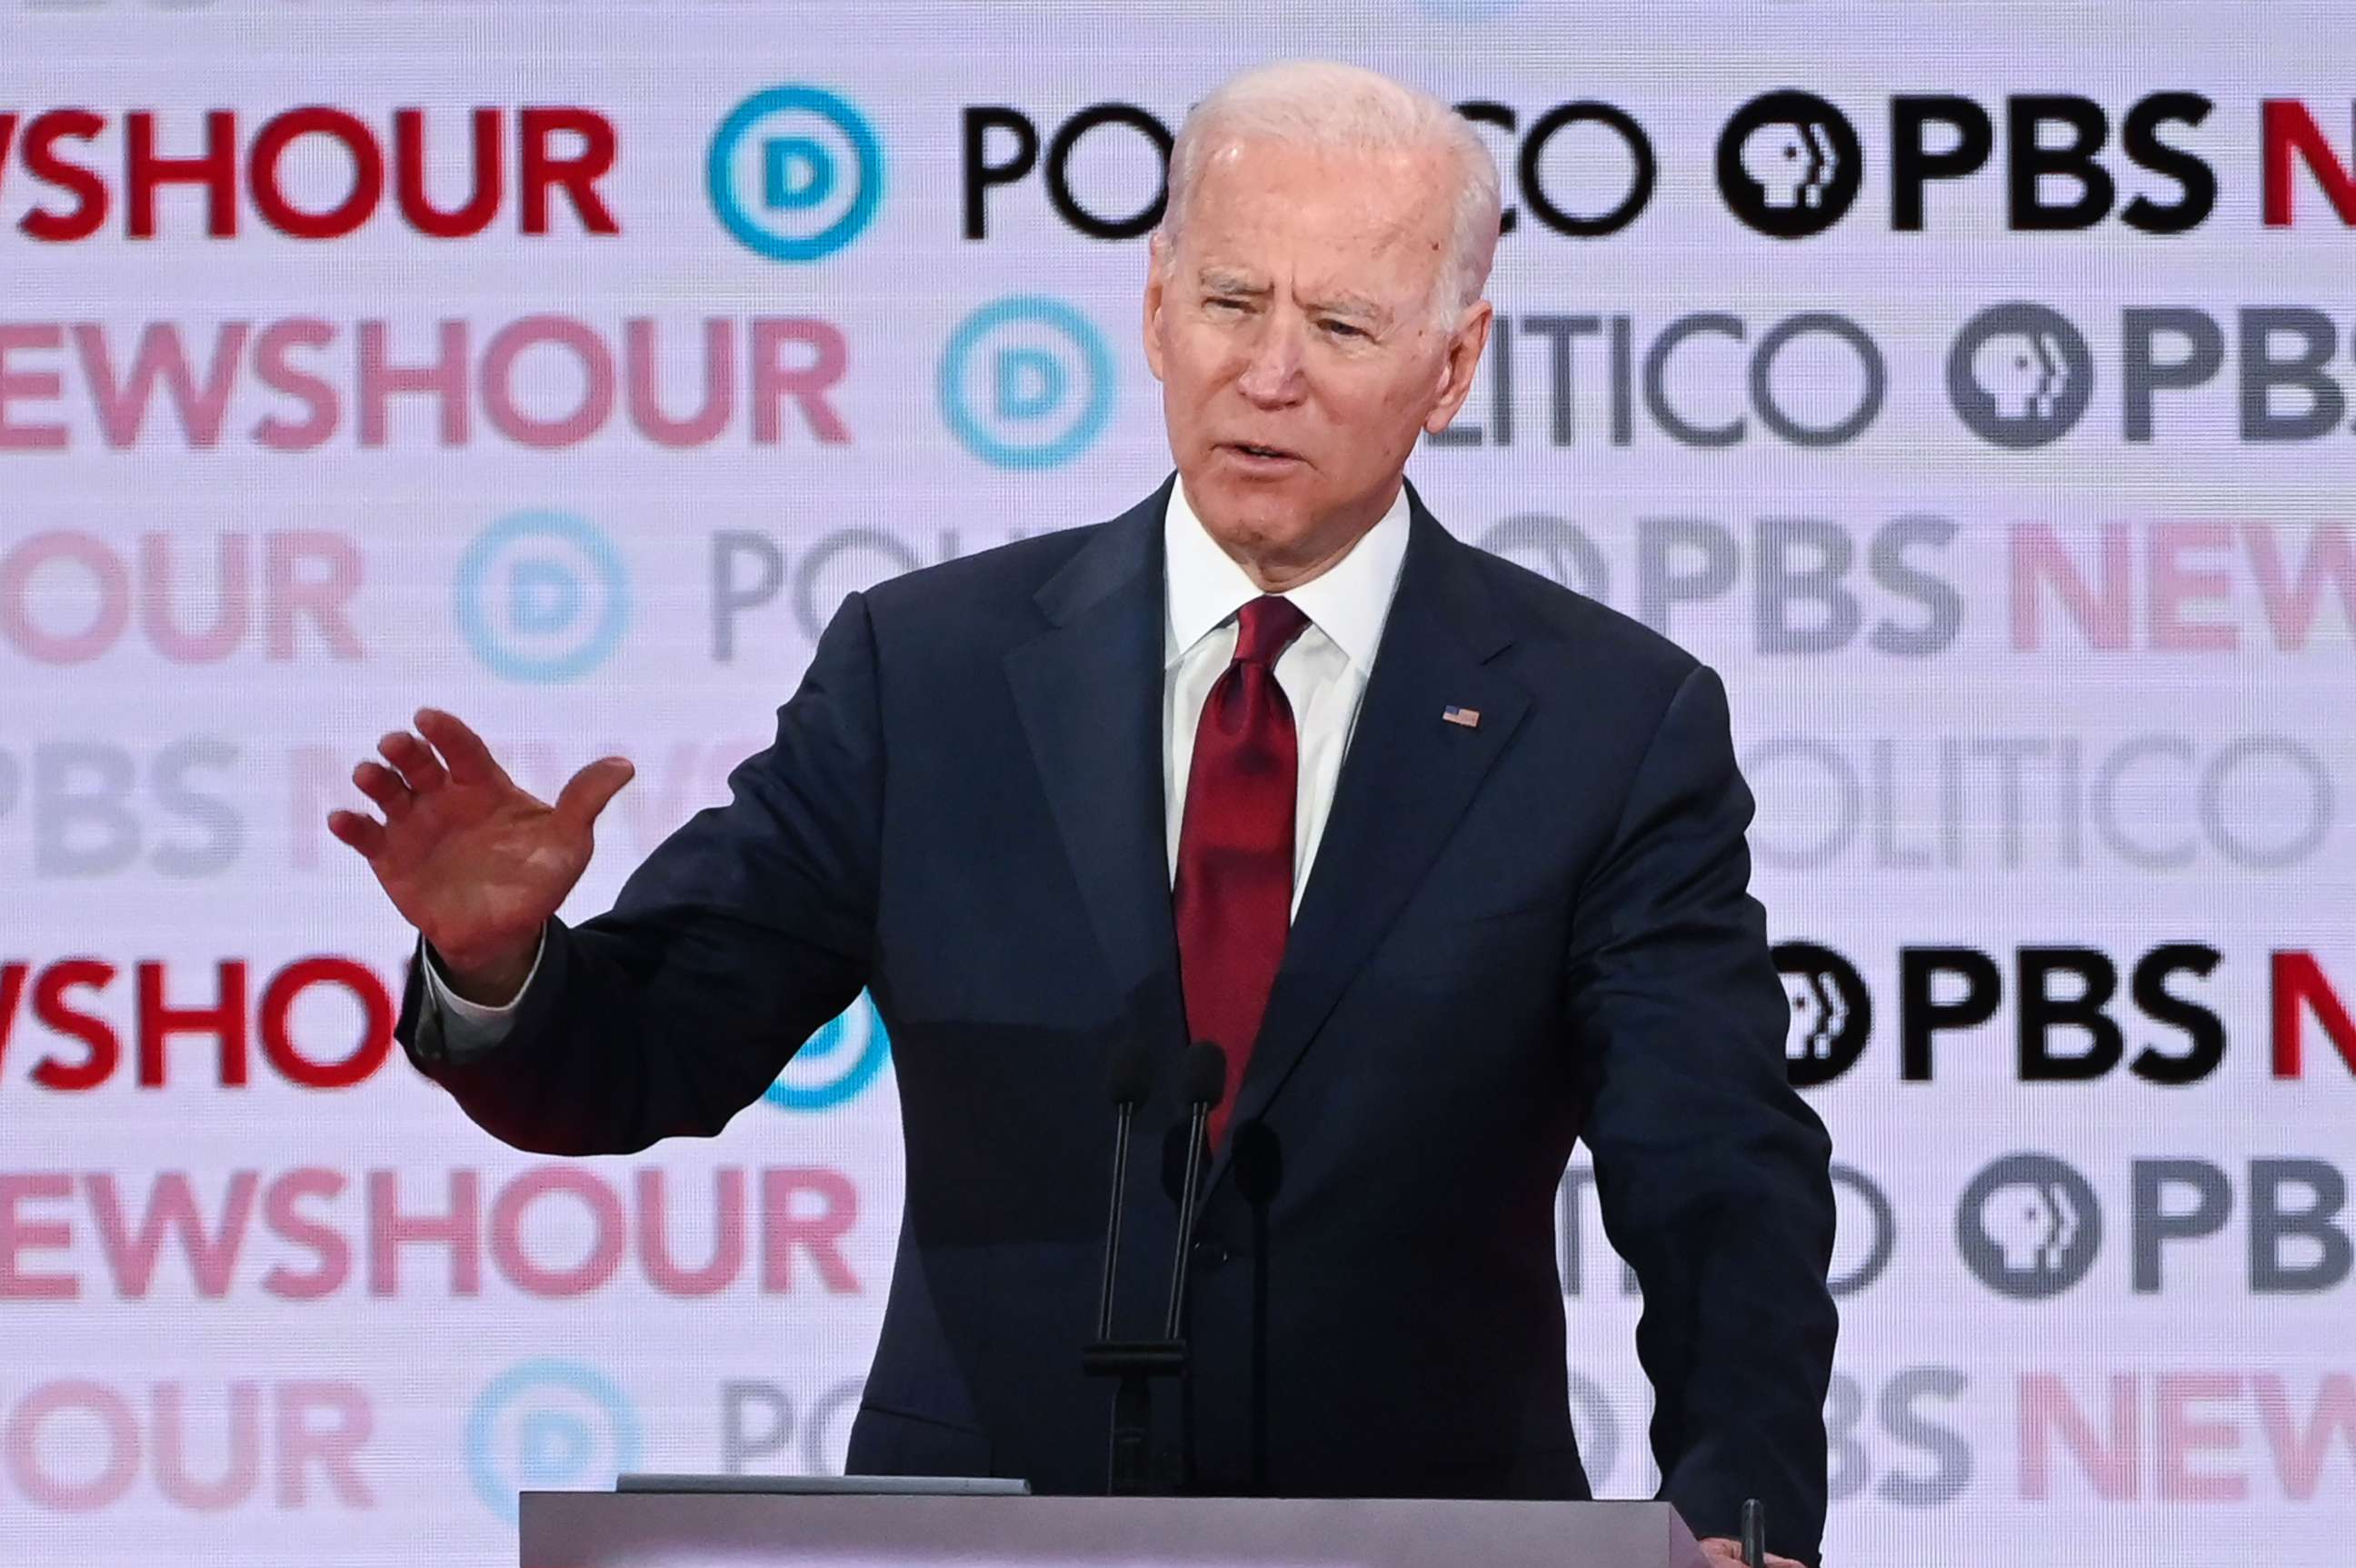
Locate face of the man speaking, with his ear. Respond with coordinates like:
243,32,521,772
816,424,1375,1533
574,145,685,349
1145,141,1489,574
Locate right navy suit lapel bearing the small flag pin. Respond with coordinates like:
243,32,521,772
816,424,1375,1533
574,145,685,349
1211,487,1529,1184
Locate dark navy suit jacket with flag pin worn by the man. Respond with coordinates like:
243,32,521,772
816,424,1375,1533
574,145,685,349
398,483,1835,1559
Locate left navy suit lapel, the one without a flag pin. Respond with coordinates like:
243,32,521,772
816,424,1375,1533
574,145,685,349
1006,480,1185,1050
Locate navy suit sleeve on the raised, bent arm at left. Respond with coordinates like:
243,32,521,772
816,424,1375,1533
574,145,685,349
395,594,884,1154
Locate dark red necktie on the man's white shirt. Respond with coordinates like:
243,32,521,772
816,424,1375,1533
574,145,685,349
1171,595,1310,1146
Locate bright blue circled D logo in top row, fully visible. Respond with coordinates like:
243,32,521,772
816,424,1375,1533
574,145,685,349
704,85,884,262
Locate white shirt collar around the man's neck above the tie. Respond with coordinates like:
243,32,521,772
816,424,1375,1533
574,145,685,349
1162,480,1406,671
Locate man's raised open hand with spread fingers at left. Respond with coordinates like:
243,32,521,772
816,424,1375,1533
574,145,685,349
327,709,634,1005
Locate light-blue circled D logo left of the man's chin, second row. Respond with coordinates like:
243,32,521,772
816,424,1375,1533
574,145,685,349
940,295,1112,468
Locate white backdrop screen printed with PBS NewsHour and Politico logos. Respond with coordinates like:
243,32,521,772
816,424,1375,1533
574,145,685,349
0,0,2356,1565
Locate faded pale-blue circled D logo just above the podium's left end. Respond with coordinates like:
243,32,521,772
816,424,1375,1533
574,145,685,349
466,1358,641,1523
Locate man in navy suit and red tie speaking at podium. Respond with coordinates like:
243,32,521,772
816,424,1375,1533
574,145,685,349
330,66,1835,1561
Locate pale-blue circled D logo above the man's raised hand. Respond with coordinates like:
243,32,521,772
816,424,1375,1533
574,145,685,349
454,511,629,683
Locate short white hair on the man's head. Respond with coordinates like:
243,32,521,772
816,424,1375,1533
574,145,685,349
1154,59,1501,327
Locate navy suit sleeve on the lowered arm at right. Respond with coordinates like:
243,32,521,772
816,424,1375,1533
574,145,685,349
1572,666,1835,1563
